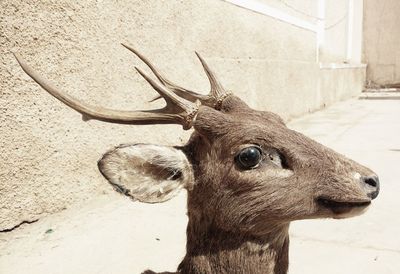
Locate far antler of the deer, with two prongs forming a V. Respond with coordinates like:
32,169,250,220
122,44,231,109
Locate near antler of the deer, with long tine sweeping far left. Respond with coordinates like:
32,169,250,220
14,53,199,129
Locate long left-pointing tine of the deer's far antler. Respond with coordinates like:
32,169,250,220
121,43,206,102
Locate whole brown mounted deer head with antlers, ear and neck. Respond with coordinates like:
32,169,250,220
14,44,380,274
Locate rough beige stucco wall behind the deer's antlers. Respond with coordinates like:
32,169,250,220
0,0,363,230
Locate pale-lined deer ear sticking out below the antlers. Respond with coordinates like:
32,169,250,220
98,144,194,203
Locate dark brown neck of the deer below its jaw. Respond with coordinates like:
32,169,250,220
179,219,289,274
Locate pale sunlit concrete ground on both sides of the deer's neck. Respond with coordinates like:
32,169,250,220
0,100,400,274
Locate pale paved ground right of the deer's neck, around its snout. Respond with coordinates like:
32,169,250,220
290,97,400,274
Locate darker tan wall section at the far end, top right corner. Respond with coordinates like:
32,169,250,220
363,0,400,86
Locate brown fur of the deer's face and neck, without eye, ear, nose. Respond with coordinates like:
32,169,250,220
152,96,373,274
